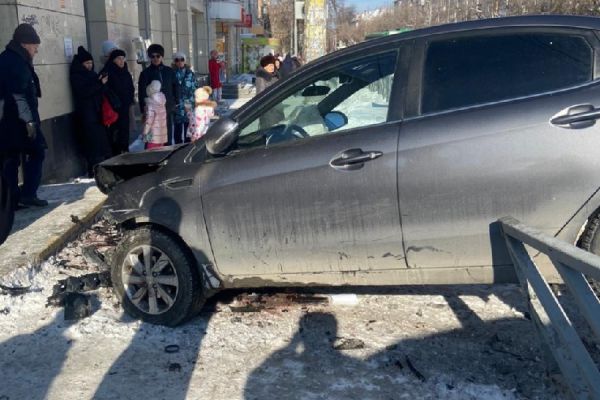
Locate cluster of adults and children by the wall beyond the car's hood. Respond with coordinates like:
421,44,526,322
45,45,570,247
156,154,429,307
70,41,224,175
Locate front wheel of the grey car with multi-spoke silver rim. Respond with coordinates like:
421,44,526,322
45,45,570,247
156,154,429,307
111,226,206,326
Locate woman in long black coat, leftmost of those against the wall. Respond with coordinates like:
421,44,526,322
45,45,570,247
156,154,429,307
70,46,111,176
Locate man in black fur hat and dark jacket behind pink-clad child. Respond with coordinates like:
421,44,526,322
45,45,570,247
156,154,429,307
138,44,179,145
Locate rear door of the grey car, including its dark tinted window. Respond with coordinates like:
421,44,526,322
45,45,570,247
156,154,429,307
398,27,600,282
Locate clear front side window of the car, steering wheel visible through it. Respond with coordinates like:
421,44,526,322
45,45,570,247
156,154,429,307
238,51,397,147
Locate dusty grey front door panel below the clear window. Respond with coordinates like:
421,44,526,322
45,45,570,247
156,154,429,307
198,124,406,275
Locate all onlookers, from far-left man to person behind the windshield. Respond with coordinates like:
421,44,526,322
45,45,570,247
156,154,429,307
0,23,301,243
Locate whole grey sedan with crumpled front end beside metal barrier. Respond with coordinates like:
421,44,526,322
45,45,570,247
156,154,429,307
96,16,600,325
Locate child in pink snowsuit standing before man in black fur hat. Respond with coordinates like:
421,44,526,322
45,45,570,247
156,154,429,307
142,81,167,149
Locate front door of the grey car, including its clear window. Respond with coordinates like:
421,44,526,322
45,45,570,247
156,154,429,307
200,46,405,285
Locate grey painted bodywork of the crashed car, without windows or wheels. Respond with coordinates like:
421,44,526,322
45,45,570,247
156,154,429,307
97,16,600,286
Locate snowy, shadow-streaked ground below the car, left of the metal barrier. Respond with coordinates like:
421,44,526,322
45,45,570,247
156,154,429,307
0,223,576,400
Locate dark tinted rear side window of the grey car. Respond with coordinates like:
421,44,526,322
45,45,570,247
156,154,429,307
421,32,593,113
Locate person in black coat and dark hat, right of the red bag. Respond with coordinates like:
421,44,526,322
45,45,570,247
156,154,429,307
100,49,134,155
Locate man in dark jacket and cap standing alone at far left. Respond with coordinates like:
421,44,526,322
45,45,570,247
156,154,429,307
0,24,48,207
